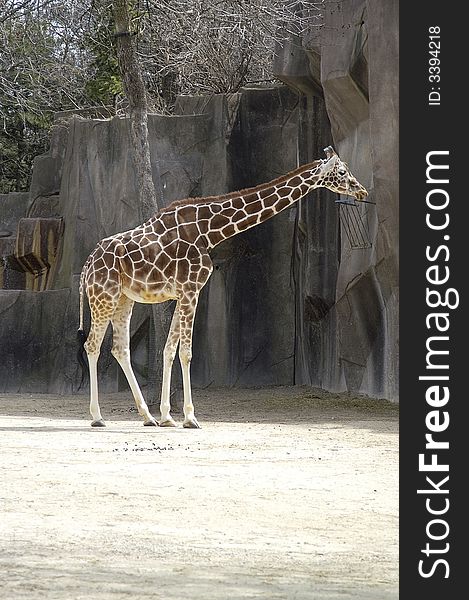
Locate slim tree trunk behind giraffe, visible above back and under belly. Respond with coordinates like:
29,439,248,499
112,0,180,405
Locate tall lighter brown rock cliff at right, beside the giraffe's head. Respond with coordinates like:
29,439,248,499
275,0,399,399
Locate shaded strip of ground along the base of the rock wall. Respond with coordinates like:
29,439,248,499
0,386,399,431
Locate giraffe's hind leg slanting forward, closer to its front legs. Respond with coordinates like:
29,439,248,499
111,295,158,426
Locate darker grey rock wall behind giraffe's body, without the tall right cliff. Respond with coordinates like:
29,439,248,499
0,86,337,392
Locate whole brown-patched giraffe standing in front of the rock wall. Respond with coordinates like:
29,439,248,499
78,146,368,428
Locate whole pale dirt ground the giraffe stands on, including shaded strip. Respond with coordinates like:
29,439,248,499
0,387,398,600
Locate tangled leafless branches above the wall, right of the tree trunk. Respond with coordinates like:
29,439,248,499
132,0,324,111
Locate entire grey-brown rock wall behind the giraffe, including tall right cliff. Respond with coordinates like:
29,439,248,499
0,0,398,399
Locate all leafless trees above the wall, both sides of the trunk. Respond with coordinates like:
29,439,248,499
0,0,328,191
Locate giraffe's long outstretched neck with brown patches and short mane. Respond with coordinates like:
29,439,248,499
206,161,320,248
